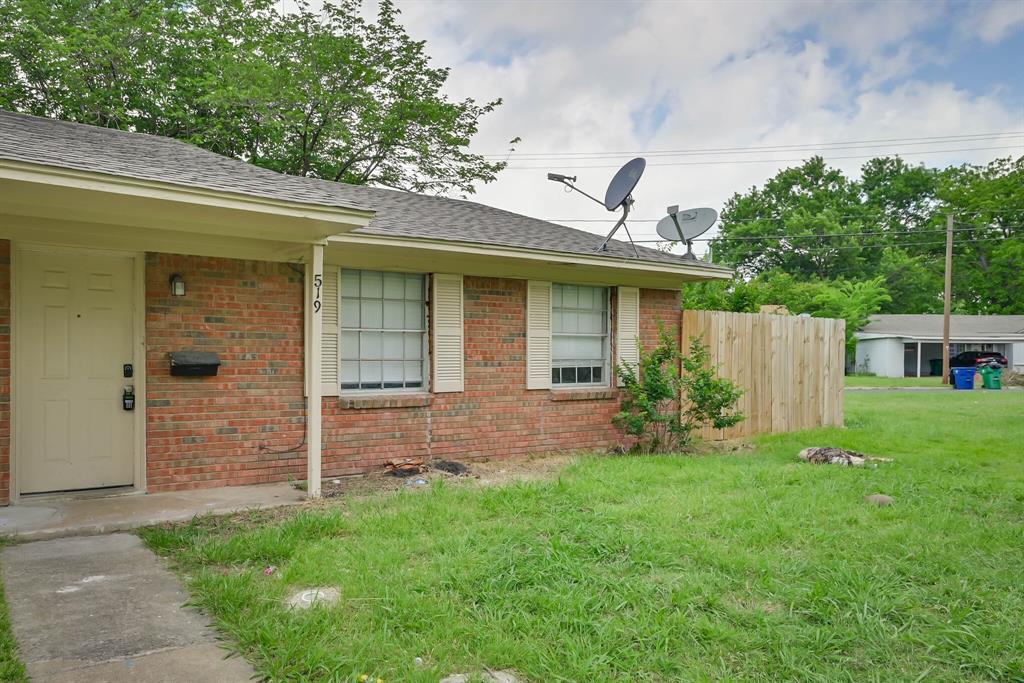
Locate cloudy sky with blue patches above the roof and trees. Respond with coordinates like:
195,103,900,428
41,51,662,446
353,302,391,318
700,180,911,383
380,0,1024,248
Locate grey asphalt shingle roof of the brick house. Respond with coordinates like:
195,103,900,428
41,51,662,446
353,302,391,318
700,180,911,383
0,111,705,266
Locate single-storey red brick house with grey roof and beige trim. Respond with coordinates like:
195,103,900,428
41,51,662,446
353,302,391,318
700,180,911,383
0,112,730,502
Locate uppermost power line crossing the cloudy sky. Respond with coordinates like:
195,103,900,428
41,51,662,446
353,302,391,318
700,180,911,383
491,131,1024,161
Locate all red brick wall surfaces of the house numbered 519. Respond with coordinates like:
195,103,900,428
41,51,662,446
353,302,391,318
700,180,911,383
6,250,680,497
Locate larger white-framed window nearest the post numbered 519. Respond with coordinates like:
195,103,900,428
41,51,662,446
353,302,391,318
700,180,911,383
340,268,427,391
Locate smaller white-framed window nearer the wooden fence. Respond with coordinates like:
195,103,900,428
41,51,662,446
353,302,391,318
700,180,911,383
551,284,608,386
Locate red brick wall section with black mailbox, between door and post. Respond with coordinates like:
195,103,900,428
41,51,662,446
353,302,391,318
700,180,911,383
145,254,306,492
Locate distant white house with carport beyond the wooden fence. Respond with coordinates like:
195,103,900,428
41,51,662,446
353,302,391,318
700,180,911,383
856,314,1024,377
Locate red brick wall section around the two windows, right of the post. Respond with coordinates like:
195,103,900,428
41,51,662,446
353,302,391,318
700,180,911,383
324,276,681,476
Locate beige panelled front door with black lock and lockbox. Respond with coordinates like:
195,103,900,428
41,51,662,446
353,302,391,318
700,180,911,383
14,249,137,494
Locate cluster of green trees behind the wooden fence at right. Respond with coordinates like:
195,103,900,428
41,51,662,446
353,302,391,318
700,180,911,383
700,152,1024,317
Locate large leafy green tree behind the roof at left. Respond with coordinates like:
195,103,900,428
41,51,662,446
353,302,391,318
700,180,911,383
0,0,504,194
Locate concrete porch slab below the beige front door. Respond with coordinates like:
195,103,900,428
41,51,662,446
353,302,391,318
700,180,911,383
0,483,305,541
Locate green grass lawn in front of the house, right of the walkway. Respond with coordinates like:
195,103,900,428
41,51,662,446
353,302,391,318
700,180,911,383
142,392,1024,683
